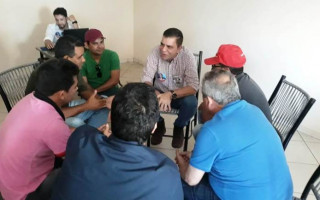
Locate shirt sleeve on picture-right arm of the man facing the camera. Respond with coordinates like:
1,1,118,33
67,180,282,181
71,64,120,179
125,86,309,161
184,51,199,91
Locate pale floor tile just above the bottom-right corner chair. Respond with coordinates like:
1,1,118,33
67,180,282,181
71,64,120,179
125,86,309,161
285,141,318,164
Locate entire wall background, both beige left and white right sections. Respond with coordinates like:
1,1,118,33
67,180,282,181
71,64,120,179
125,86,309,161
0,0,320,134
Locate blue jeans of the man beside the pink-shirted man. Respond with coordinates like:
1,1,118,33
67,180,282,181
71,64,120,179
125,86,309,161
66,99,109,128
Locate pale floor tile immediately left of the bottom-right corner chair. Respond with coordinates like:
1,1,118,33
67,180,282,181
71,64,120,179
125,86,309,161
288,162,318,193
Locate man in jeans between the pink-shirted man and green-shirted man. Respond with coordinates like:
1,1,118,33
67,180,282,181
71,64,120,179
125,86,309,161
26,36,108,128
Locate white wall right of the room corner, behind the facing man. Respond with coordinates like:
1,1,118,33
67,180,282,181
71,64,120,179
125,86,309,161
134,0,320,136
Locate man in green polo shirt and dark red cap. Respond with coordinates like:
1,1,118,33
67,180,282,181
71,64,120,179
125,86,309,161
81,29,120,96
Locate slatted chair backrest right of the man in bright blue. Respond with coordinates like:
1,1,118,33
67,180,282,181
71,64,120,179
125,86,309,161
268,75,316,149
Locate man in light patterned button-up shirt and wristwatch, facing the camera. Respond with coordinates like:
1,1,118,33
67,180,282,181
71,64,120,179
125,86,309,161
142,28,199,148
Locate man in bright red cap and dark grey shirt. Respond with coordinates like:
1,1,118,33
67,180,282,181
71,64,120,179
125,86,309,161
199,44,272,125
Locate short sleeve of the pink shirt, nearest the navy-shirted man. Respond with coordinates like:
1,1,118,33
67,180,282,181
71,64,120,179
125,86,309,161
44,118,71,155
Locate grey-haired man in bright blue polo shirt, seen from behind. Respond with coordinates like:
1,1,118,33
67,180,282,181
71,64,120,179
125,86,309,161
176,69,293,200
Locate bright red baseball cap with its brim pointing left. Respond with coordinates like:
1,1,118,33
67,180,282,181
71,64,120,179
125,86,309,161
204,44,246,68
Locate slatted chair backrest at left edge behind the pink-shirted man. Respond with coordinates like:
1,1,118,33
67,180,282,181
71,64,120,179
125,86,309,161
0,62,39,112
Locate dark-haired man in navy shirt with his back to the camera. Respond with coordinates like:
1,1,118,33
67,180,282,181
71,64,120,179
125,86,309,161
52,83,183,200
